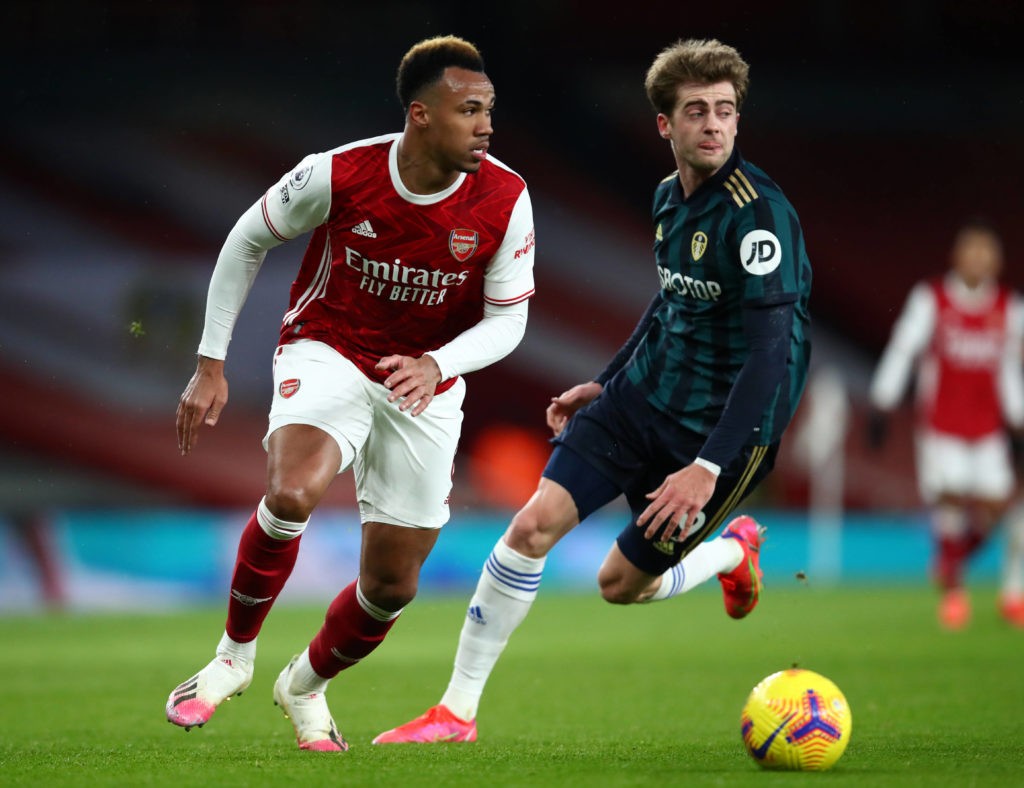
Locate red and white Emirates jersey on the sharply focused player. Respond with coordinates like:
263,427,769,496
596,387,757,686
262,134,534,393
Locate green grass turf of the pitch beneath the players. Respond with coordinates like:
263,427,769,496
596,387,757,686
0,586,1024,788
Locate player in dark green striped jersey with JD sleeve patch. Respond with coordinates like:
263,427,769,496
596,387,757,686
375,40,811,744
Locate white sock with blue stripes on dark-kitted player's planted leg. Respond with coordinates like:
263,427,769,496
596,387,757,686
441,537,545,719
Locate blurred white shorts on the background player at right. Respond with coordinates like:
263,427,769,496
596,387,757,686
916,430,1014,504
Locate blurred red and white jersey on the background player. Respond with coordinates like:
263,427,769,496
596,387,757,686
871,274,1024,440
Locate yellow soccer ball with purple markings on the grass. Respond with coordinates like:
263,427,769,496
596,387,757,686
740,668,853,771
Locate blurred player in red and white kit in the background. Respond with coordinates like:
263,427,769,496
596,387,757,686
868,220,1024,629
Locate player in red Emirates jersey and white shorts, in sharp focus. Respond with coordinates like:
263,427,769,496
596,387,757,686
166,36,534,751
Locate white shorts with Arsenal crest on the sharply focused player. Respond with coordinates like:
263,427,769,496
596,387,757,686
263,340,466,528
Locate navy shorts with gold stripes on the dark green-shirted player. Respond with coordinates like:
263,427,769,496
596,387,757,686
544,375,778,575
